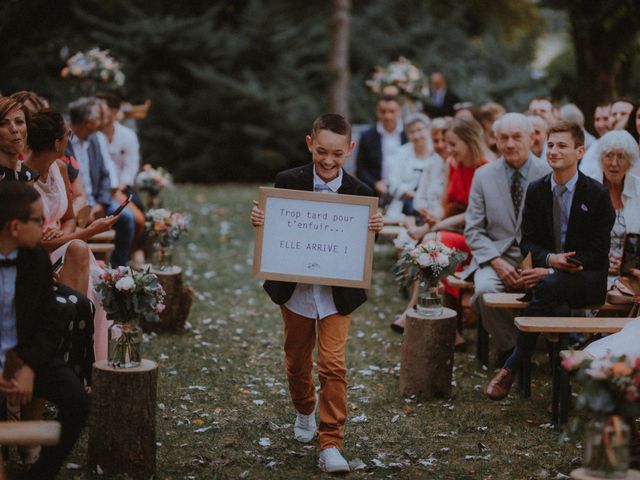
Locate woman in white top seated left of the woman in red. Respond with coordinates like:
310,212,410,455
386,113,431,216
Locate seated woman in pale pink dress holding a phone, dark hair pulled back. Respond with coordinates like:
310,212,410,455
27,110,118,360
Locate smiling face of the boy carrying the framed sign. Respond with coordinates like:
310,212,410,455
306,130,356,182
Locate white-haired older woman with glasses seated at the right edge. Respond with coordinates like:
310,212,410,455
593,130,640,285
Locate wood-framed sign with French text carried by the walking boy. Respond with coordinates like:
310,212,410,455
253,187,378,288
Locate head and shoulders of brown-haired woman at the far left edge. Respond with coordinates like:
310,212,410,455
0,97,37,183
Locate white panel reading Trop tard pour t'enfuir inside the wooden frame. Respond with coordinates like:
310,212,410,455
260,187,370,284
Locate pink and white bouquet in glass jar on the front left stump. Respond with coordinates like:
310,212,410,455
96,267,165,368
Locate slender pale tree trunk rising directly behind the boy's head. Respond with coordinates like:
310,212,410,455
328,0,351,119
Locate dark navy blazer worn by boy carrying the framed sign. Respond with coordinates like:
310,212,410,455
263,163,374,315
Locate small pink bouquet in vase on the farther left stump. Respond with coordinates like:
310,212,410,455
144,208,189,270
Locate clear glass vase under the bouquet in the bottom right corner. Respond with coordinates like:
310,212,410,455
583,415,629,478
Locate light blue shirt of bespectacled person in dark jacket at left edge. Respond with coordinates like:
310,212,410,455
0,250,18,368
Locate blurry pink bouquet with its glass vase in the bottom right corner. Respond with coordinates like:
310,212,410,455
562,352,640,478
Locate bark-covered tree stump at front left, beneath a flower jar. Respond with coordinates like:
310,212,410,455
88,359,158,480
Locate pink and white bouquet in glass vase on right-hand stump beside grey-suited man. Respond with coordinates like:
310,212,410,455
396,240,467,316
